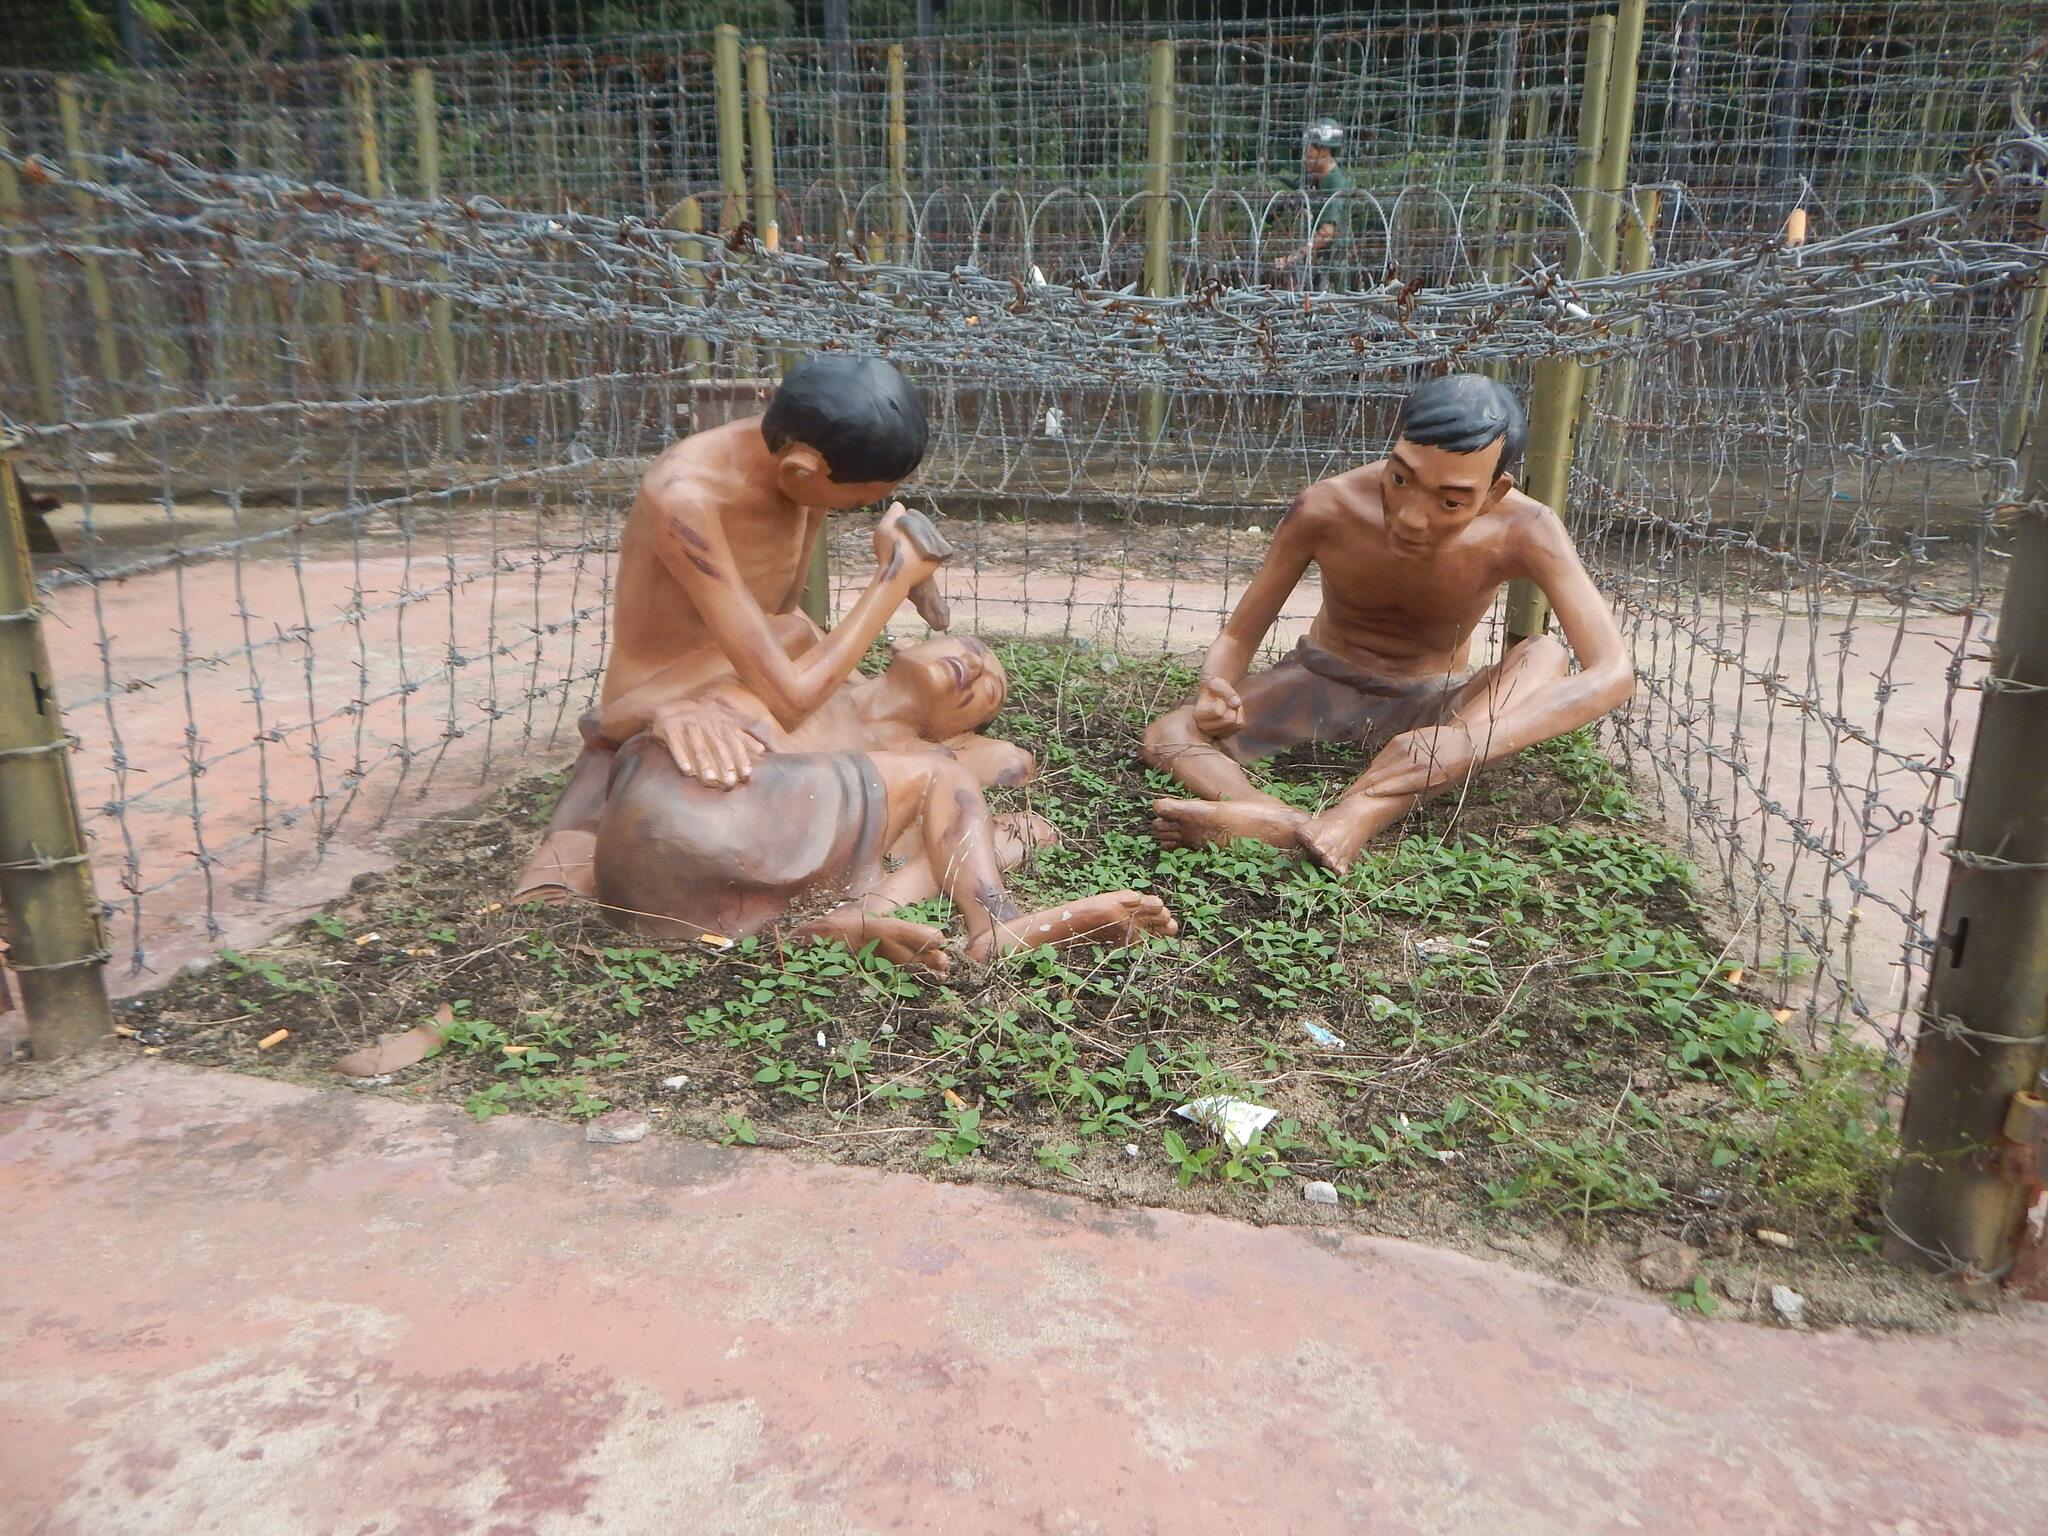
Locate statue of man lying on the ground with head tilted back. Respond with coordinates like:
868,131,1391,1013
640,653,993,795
592,616,1178,971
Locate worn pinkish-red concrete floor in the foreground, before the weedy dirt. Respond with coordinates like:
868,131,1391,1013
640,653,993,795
0,1063,2048,1536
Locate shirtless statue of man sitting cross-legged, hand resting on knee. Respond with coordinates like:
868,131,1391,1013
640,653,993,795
1145,375,1634,872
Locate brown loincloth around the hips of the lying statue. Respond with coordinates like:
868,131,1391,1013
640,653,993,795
594,733,889,938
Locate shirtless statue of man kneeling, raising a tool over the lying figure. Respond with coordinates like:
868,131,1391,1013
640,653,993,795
514,352,938,901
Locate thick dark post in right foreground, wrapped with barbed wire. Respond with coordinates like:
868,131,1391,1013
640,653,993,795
1884,382,2048,1282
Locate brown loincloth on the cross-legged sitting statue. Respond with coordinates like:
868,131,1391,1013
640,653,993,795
1217,641,1477,762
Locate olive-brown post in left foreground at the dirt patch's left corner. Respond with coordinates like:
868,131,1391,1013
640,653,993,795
0,428,115,1061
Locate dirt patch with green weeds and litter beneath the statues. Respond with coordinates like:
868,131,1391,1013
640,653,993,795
129,645,1954,1327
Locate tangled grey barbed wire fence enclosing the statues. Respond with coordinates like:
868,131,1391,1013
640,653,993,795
0,6,2044,1047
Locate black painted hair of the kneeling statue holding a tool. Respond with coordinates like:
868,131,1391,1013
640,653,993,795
762,352,930,485
